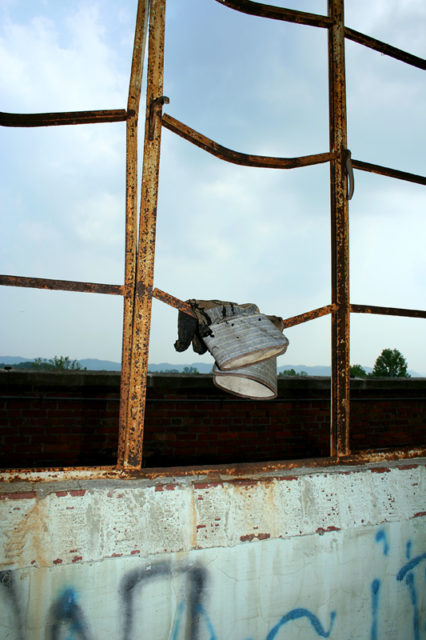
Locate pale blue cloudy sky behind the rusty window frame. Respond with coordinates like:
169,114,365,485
0,0,426,375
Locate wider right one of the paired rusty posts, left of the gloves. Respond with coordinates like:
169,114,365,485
118,0,165,470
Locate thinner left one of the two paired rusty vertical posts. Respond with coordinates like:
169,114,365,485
117,0,149,466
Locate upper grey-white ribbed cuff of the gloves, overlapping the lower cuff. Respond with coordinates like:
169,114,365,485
203,313,288,371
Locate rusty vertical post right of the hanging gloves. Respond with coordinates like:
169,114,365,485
328,0,350,456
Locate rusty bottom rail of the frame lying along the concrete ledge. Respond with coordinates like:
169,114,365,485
0,447,426,484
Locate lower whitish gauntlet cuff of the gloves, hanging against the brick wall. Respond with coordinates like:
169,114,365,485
213,358,277,400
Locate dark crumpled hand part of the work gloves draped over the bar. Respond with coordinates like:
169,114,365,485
175,299,283,355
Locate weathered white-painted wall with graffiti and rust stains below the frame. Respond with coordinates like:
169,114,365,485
0,459,426,640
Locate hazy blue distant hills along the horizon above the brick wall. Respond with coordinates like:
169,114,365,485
0,356,426,378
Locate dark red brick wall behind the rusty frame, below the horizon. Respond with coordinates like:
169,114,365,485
0,371,426,468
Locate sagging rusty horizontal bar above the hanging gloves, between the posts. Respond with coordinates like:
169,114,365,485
162,113,333,169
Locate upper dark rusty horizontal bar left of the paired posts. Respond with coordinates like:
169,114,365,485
0,109,132,127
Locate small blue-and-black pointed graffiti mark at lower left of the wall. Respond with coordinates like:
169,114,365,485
47,588,91,640
